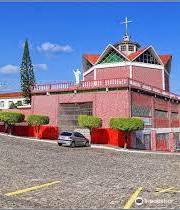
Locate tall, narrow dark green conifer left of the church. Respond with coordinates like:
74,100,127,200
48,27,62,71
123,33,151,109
20,40,35,103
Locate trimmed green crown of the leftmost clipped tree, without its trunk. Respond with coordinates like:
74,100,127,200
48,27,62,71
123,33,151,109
0,111,25,125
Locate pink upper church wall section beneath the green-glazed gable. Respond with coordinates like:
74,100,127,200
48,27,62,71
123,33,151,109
96,66,130,80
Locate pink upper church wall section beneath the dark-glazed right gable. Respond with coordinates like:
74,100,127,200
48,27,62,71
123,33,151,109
132,66,163,89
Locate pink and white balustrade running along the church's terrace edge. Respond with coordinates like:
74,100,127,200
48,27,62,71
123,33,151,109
32,78,180,100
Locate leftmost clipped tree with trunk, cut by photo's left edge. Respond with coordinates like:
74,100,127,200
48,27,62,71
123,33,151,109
0,111,25,134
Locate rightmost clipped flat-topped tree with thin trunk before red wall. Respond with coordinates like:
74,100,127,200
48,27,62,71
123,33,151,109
109,117,144,148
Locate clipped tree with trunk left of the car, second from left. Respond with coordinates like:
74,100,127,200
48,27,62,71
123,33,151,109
27,114,49,138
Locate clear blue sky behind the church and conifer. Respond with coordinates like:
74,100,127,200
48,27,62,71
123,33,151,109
0,2,180,93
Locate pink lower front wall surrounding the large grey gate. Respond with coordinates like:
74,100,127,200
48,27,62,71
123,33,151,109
32,90,129,127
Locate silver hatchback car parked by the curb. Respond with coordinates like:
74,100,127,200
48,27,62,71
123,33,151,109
58,131,90,147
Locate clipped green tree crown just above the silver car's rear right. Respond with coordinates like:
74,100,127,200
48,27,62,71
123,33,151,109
78,115,102,129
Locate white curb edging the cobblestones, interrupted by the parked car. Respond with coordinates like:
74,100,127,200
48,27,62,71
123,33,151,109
0,133,180,156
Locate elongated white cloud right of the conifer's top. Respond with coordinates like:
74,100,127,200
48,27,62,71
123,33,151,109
37,42,73,53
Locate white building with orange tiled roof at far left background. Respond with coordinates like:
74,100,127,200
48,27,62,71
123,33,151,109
0,92,24,110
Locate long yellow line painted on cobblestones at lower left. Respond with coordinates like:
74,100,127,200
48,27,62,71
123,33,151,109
5,181,60,196
